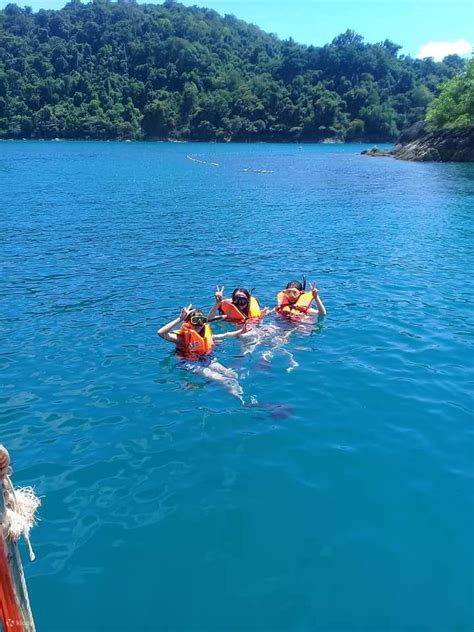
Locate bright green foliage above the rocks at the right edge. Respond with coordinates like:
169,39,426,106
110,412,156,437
426,59,474,129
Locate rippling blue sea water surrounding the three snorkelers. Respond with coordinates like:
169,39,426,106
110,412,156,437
0,142,474,632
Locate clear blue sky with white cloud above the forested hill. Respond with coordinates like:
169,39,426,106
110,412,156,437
0,0,474,57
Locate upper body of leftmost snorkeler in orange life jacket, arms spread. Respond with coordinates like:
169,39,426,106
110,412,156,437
156,305,246,357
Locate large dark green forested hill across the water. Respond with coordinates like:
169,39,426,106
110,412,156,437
0,0,463,141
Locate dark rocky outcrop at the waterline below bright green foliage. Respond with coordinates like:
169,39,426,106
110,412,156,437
393,121,474,162
